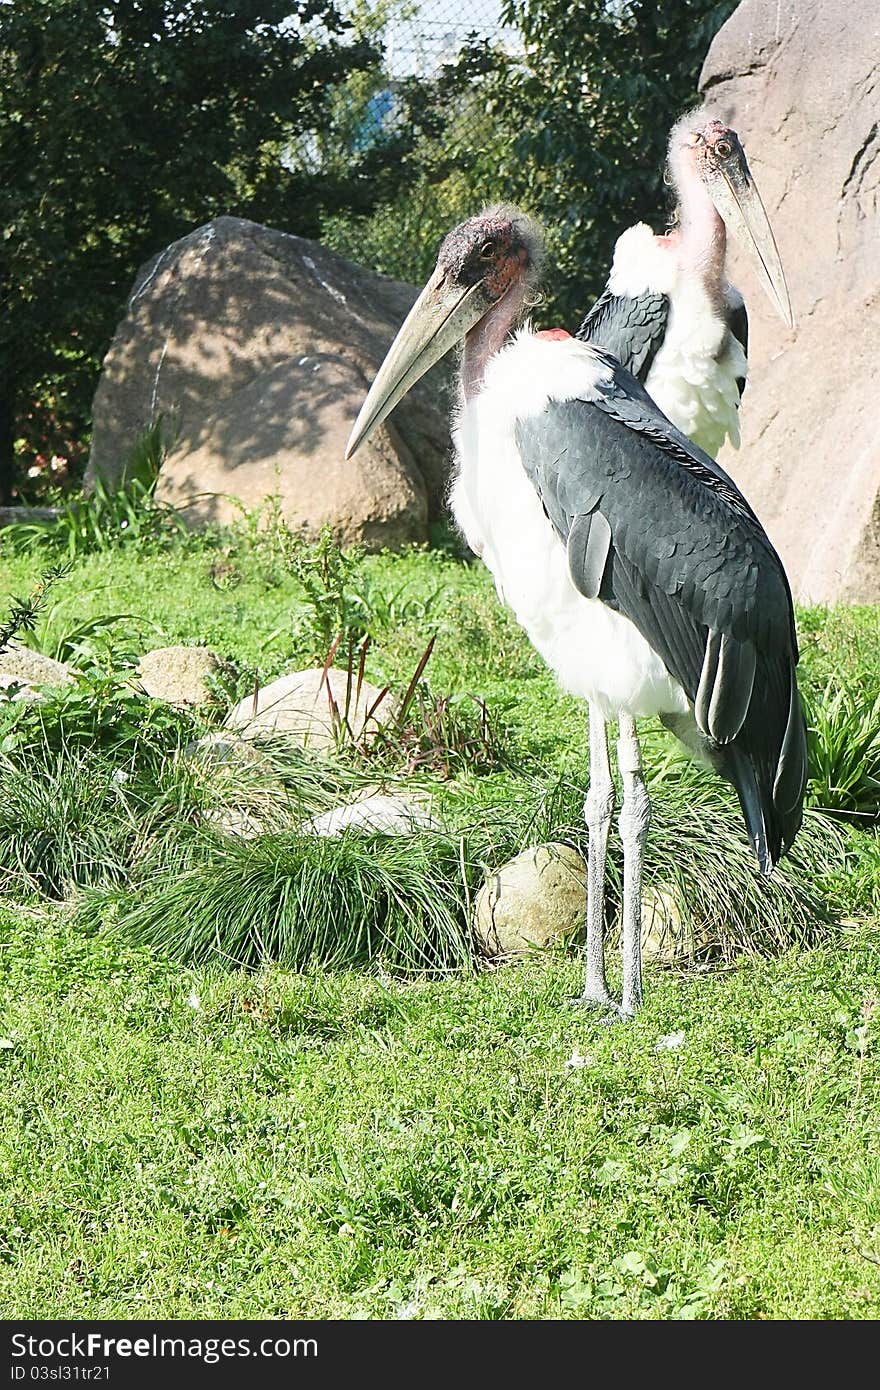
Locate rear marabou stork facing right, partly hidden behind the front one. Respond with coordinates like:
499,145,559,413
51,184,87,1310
577,108,794,457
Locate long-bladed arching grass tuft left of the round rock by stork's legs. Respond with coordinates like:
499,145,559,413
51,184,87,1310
82,833,478,974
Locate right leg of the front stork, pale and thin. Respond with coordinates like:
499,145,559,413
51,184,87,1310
617,714,651,1017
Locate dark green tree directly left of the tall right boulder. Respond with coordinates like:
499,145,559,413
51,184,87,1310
471,0,737,325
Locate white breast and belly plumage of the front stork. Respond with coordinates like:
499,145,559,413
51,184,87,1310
450,329,690,717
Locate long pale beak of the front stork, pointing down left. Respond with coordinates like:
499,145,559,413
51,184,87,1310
345,265,489,459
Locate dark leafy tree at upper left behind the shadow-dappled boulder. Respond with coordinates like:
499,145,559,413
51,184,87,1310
0,0,381,502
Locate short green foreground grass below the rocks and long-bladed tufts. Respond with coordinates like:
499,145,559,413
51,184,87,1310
0,910,880,1319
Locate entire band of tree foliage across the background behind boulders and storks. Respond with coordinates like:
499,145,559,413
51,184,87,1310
0,0,735,503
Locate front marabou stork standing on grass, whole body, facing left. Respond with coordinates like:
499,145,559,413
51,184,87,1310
346,207,806,1017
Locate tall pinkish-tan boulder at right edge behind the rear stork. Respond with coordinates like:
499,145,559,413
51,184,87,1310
701,0,880,602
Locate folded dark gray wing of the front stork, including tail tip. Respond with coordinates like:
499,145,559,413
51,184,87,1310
516,364,806,872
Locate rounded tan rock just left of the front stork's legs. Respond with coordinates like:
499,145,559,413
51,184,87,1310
474,844,587,955
